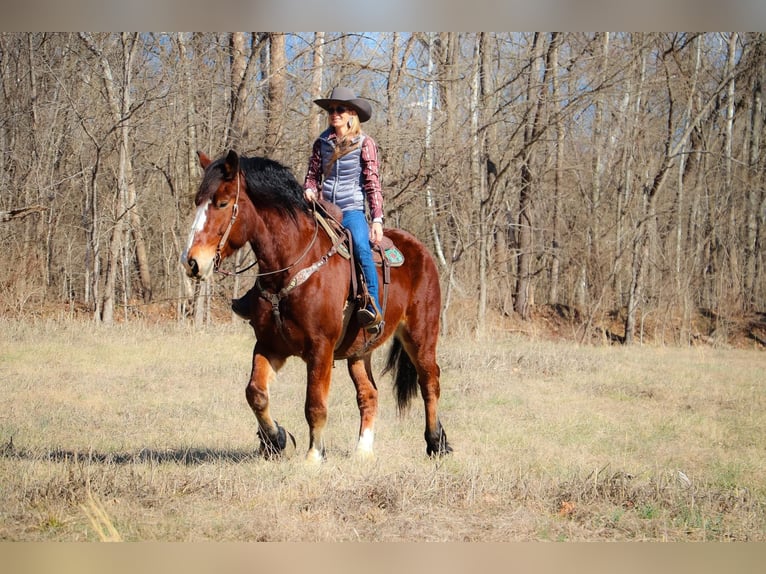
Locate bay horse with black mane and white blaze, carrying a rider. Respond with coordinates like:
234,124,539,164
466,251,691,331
181,150,452,462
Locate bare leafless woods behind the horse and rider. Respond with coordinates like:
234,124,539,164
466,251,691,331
0,32,766,344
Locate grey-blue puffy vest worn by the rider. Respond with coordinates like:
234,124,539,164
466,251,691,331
319,129,364,211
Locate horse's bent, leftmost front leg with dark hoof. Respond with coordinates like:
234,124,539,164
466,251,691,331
245,343,295,458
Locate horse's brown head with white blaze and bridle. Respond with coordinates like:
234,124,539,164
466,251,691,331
181,151,247,279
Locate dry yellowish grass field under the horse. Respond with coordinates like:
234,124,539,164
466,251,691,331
0,319,766,541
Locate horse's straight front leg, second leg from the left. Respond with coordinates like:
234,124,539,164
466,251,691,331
305,345,333,462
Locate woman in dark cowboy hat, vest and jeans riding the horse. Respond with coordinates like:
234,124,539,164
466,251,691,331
303,87,383,331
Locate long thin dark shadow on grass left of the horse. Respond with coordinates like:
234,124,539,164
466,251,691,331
0,439,261,466
